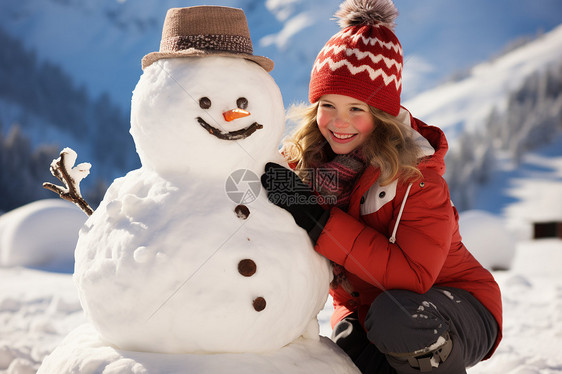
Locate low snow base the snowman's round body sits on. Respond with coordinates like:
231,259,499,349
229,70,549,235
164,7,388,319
37,324,359,374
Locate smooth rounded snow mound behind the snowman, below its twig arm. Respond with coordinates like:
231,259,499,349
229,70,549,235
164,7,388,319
0,199,87,273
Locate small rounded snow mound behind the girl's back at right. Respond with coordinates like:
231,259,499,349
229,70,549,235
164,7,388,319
459,210,516,270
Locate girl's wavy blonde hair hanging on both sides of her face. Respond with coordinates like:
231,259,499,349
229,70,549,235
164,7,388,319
282,103,421,186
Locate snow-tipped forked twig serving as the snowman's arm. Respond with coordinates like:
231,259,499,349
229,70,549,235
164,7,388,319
43,148,94,216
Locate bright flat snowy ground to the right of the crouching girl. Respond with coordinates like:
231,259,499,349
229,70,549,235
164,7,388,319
469,240,562,374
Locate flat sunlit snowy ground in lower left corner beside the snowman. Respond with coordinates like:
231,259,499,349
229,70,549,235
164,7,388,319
0,267,85,374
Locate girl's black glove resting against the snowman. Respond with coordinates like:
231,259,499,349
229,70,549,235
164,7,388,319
261,162,330,243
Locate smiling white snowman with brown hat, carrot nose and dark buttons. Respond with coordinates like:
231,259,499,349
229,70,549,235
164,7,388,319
41,6,356,373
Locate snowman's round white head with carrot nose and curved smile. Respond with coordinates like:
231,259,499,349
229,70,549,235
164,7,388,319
131,56,284,175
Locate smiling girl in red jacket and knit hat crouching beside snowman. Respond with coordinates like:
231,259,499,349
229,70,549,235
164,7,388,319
262,0,502,374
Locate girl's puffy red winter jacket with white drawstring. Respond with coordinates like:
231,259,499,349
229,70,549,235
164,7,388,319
315,109,502,358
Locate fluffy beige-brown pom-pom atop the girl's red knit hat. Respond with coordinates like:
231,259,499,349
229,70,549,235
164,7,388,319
335,0,398,30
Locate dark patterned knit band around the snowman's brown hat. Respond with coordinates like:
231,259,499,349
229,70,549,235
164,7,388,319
160,35,253,55
